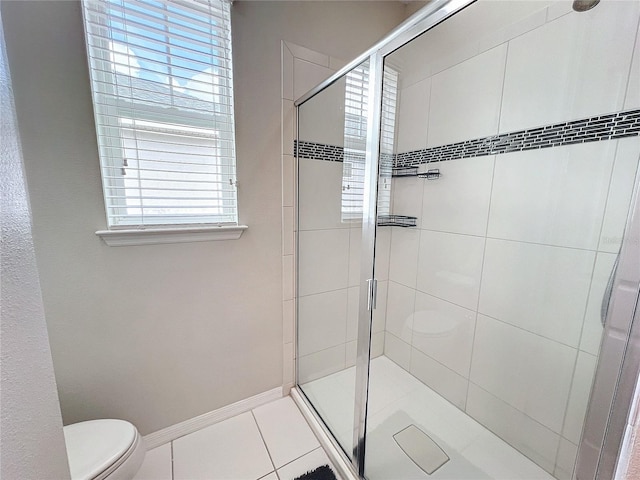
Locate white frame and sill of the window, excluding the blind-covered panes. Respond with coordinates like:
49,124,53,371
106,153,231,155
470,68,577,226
82,0,247,242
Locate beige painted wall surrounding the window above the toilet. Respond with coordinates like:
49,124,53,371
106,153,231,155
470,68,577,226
2,1,405,434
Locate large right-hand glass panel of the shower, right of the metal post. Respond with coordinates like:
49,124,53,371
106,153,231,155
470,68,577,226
365,1,640,480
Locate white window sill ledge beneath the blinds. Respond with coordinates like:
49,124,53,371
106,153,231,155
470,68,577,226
96,225,249,247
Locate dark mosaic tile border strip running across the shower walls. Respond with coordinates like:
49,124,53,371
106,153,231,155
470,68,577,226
294,109,640,167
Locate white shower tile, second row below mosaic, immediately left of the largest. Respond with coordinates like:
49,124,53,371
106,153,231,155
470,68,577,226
416,230,485,310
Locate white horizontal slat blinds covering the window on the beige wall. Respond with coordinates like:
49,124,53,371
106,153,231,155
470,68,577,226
83,0,238,228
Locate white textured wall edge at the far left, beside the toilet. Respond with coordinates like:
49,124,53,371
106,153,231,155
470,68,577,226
0,10,69,480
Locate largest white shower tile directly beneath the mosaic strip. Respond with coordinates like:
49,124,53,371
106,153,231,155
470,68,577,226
488,142,616,250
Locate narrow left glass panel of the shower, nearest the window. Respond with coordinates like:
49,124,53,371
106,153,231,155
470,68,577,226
297,61,373,457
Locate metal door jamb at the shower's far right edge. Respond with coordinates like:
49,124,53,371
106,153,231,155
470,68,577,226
574,163,640,480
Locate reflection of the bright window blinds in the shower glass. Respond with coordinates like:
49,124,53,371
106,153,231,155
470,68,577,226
342,65,398,222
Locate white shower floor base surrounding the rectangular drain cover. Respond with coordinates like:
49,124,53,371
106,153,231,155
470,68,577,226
301,356,554,480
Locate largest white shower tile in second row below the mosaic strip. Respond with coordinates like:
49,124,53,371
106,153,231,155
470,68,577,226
478,239,595,347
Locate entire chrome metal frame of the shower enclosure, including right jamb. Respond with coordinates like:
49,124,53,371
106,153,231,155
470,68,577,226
294,0,640,480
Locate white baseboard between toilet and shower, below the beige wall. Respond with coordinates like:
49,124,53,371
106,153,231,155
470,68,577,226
148,387,283,450
